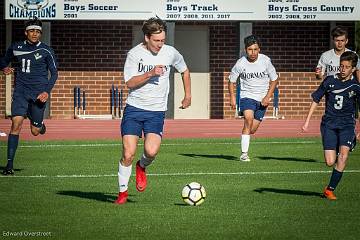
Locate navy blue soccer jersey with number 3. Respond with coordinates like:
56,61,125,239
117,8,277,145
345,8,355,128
311,75,360,123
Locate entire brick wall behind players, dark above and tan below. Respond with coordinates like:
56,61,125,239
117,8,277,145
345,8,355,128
0,19,354,119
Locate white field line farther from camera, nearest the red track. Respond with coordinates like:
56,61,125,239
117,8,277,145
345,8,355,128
0,140,318,148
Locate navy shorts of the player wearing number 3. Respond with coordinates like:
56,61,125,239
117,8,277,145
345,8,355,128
320,123,355,150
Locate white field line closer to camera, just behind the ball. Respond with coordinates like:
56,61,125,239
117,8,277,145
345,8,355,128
0,169,360,179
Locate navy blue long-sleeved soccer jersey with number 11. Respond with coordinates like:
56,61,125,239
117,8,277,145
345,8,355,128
0,41,58,93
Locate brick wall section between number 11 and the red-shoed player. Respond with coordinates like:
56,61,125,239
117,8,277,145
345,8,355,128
51,21,132,119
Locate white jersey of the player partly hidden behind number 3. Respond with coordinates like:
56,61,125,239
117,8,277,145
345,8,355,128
317,48,360,77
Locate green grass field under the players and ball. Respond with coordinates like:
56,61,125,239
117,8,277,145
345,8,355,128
0,138,360,240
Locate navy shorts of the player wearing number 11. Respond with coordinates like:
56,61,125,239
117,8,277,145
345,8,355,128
11,88,46,128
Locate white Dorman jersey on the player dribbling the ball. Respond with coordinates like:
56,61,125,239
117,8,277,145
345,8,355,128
124,43,187,111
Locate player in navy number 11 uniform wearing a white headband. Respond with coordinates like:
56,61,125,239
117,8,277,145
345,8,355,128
0,18,58,175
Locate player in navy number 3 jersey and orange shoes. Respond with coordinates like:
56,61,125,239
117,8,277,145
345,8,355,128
302,51,360,200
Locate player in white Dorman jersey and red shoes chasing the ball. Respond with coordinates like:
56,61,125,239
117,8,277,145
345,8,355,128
115,18,191,204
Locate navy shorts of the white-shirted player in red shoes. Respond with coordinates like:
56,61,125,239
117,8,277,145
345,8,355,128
121,105,165,137
